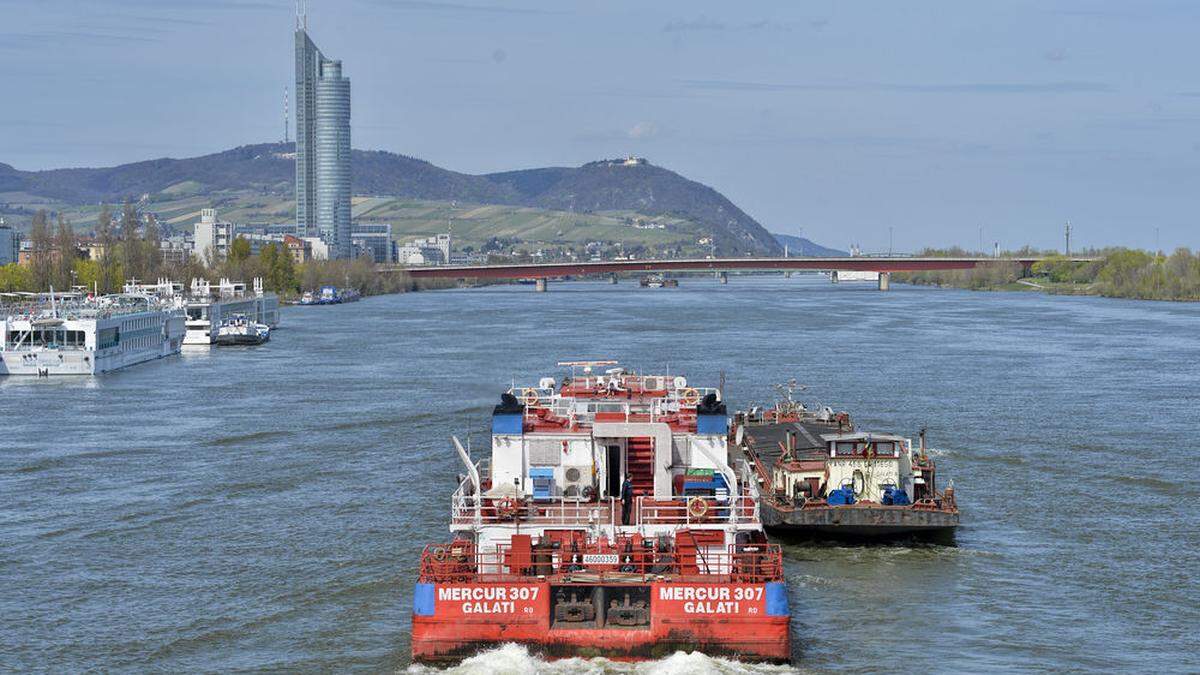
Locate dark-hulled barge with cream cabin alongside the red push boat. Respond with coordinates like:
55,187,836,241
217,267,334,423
731,392,959,540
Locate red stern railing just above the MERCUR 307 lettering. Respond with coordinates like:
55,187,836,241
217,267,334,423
420,538,784,584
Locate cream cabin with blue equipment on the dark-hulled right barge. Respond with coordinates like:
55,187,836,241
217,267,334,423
772,432,925,506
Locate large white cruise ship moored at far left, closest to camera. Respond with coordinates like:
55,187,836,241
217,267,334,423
0,294,185,377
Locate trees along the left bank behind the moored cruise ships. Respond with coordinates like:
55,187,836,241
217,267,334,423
0,203,416,297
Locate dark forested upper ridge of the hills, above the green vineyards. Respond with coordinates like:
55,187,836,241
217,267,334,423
0,143,782,255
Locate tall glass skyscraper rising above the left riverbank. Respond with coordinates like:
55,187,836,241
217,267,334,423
295,11,352,258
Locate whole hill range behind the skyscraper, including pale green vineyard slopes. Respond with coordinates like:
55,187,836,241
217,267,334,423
0,143,782,255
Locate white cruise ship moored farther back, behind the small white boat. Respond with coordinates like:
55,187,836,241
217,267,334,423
176,279,280,345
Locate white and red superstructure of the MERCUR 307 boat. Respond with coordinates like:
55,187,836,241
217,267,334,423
451,369,757,534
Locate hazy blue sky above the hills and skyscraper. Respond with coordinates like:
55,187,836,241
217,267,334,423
0,0,1200,251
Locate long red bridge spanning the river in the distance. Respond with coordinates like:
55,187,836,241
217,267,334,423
379,256,1094,289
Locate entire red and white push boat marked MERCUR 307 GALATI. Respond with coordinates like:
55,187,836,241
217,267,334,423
413,362,791,663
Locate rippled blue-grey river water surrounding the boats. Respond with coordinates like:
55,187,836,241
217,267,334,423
0,277,1200,673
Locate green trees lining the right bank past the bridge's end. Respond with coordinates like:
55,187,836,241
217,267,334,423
893,247,1200,300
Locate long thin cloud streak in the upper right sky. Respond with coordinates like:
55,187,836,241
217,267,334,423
682,79,1114,94
